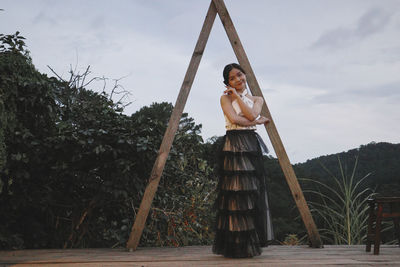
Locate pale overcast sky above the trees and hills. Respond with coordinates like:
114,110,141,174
0,0,400,163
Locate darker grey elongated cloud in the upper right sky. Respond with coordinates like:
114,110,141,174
311,8,392,49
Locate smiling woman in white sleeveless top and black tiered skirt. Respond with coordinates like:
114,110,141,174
213,63,273,258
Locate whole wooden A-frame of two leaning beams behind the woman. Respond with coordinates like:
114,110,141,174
127,0,322,251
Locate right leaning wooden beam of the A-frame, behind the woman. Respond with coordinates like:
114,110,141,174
212,0,322,247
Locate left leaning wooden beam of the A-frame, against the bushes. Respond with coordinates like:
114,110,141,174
126,2,217,250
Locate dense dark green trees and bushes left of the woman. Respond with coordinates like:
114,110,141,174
0,33,215,249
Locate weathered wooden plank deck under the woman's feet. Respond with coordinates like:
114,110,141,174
0,245,400,267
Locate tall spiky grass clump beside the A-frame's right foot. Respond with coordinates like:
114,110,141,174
301,156,374,245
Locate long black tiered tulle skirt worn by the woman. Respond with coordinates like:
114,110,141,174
213,130,273,258
